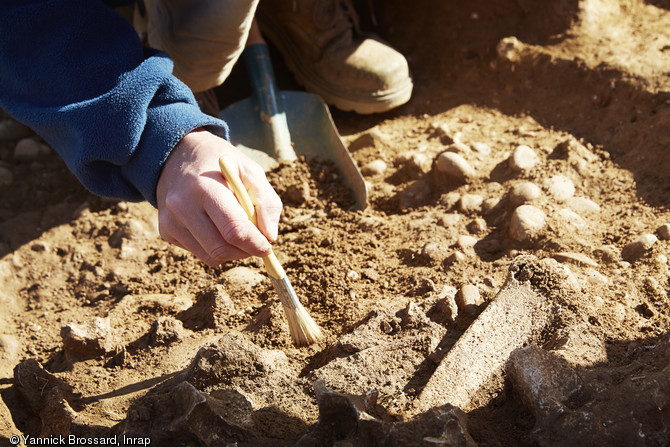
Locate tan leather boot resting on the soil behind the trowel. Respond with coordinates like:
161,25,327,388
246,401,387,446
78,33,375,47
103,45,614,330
256,0,412,114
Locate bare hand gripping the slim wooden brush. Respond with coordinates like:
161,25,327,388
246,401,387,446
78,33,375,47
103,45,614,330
156,129,282,266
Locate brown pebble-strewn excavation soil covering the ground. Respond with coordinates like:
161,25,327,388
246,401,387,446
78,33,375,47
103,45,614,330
0,0,670,446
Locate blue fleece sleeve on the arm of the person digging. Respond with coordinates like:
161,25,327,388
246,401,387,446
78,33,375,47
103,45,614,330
0,0,228,206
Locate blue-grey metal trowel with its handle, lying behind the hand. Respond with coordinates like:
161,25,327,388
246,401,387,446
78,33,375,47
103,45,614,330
219,43,368,209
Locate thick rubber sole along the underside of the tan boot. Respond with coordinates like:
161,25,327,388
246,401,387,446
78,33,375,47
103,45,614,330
257,11,414,115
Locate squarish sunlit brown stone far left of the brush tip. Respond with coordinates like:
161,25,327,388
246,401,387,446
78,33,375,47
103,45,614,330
60,317,114,361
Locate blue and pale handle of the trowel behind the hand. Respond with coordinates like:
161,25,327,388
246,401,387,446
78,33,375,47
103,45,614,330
242,43,298,161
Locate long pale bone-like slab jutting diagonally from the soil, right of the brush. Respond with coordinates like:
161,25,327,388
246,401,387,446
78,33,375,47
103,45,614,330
412,256,565,414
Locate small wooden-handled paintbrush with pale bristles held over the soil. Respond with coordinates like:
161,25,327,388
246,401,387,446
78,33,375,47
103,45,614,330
219,157,321,346
